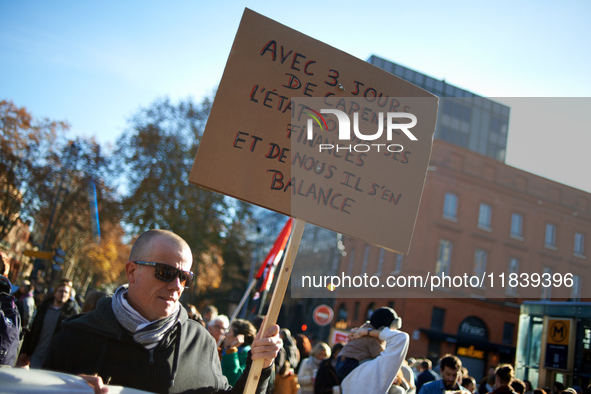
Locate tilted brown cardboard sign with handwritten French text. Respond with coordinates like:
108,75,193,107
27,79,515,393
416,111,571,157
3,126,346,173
189,9,438,253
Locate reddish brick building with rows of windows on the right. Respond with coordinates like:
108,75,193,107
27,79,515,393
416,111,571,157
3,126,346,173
334,140,591,378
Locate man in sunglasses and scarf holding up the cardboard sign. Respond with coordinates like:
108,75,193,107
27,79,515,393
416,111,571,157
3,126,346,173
44,230,282,393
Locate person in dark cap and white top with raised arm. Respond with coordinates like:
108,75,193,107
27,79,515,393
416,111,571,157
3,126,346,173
337,307,410,394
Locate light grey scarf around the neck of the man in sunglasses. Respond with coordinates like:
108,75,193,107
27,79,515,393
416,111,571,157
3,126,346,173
111,285,180,349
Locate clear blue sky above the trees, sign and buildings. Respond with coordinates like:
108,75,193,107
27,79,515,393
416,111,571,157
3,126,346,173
0,0,591,192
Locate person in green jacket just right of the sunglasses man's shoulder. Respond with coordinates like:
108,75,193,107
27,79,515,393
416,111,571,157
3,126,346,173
222,319,257,386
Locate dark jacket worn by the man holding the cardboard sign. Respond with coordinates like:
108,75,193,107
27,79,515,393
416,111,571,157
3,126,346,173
43,297,271,394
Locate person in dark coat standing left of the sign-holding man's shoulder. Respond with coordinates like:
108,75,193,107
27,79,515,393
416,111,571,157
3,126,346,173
18,279,80,368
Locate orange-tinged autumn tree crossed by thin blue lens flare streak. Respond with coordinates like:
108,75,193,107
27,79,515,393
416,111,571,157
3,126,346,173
29,138,124,287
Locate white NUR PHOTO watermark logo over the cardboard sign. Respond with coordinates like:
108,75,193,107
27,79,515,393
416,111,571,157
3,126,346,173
303,107,418,152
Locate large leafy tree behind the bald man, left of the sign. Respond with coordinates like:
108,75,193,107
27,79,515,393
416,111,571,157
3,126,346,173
116,99,250,302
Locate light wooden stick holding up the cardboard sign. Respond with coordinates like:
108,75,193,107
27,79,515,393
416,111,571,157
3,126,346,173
244,219,306,394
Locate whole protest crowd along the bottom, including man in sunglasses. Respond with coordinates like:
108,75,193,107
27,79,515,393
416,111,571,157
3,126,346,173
0,240,591,394
